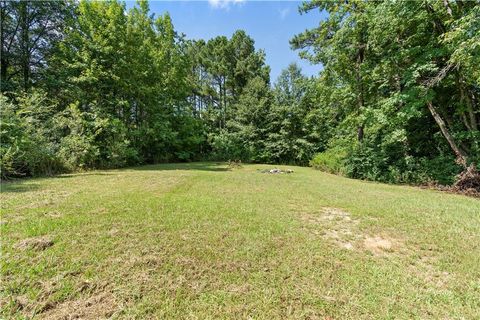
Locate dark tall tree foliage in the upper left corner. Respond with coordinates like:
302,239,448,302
0,1,74,95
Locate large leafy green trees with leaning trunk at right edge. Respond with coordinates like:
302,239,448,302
291,0,480,183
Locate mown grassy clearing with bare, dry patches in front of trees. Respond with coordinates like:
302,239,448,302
0,163,480,319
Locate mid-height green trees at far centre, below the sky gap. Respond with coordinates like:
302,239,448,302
206,64,323,164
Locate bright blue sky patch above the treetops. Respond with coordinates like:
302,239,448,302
127,0,325,82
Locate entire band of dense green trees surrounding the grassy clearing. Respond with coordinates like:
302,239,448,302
0,0,480,184
